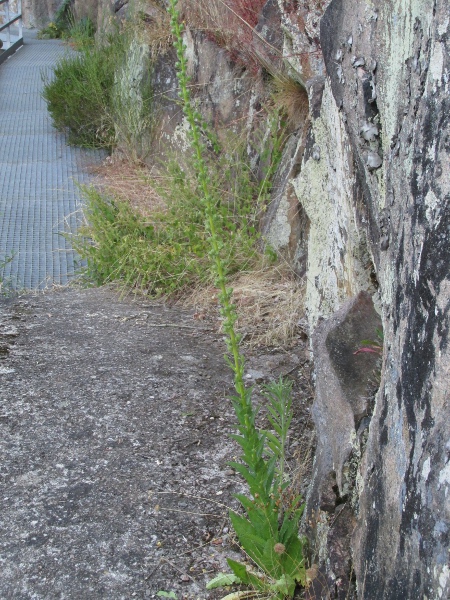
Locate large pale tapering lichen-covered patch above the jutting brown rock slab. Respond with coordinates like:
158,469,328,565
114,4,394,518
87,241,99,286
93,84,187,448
293,83,370,329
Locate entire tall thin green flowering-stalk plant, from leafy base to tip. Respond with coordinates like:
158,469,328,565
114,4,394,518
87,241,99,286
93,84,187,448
168,0,306,599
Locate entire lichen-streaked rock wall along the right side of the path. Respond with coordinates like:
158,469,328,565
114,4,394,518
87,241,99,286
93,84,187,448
262,0,450,600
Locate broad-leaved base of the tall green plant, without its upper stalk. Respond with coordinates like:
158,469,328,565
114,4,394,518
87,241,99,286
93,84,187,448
221,379,306,598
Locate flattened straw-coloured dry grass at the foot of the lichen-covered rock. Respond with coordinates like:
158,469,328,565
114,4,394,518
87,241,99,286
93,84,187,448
183,265,304,348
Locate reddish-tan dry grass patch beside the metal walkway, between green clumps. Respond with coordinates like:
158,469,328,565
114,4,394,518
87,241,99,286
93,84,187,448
88,157,165,217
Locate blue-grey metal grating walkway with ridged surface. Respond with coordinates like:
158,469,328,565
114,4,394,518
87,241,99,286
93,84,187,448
0,32,102,289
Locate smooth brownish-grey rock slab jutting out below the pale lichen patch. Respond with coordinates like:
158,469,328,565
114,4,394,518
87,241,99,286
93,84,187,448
307,292,381,598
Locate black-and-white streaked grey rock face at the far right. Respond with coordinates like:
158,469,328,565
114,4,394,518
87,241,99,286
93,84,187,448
321,0,450,599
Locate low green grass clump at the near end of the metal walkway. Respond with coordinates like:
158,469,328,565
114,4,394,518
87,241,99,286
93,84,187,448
72,150,259,296
